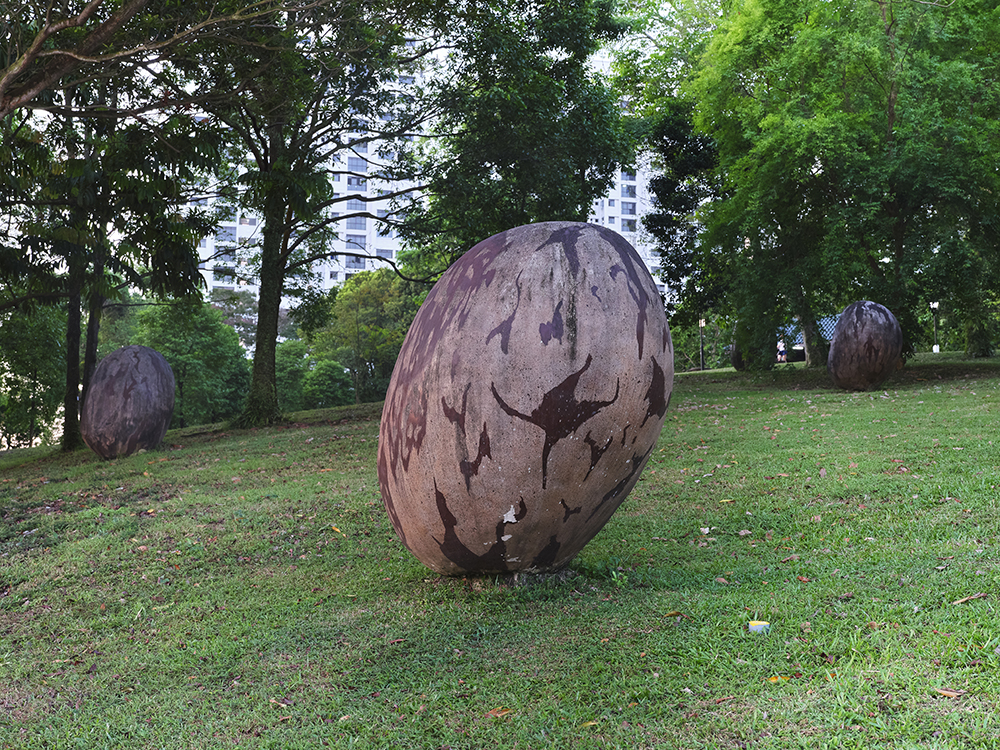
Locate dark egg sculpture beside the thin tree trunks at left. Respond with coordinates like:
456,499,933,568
80,346,174,458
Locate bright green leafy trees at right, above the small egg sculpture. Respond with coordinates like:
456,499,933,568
622,0,1000,366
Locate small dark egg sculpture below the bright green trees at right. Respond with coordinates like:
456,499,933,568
826,300,903,391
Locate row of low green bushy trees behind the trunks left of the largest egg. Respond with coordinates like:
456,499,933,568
0,269,408,448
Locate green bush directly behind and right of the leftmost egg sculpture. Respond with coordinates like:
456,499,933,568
133,303,250,427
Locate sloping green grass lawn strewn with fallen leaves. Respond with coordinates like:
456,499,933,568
0,354,1000,750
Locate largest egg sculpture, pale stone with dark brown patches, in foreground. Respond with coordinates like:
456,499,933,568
378,222,674,574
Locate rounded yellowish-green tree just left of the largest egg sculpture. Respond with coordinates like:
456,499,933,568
313,269,419,403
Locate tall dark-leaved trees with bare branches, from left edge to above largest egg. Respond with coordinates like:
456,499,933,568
0,0,630,448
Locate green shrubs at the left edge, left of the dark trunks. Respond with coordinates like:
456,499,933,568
0,307,66,448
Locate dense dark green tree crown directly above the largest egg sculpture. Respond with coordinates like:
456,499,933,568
401,0,633,276
